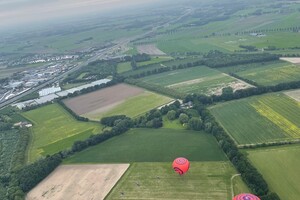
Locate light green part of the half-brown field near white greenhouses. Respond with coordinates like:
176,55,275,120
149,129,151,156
83,91,172,120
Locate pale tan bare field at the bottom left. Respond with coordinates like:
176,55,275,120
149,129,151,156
26,164,129,200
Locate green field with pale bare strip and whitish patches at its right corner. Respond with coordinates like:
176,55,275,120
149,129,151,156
141,66,251,95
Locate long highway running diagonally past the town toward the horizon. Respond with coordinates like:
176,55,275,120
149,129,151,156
0,8,193,109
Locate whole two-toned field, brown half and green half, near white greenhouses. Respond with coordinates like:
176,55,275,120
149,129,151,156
65,84,172,121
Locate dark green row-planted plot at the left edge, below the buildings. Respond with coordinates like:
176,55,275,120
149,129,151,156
0,130,19,175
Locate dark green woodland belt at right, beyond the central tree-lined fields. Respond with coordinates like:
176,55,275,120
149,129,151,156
204,50,279,68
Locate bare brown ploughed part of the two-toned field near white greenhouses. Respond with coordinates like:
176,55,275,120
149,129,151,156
64,84,144,115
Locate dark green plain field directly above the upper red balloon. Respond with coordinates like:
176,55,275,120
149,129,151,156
64,128,226,164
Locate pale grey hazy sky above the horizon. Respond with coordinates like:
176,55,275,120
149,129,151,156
0,0,153,29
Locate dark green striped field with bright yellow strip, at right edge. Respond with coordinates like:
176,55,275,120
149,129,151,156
210,93,300,144
